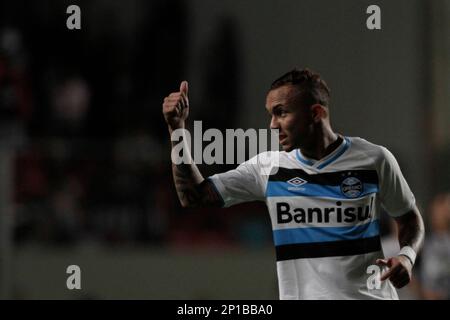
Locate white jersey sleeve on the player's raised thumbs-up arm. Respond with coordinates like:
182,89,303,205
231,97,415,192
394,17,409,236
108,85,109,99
208,156,267,207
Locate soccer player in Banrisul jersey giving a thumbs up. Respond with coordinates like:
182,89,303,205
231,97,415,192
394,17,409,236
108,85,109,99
163,69,424,299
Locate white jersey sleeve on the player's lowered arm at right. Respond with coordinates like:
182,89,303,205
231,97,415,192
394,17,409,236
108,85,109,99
378,147,416,217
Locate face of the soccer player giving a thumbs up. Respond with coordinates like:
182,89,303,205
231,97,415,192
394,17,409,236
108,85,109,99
266,85,313,151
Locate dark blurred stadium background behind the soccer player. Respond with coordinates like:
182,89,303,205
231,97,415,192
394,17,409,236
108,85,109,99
0,0,450,299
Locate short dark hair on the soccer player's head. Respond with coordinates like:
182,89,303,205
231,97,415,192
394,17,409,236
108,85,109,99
270,68,330,107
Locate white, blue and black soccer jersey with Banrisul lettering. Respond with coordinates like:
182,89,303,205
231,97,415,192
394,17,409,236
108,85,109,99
209,137,415,299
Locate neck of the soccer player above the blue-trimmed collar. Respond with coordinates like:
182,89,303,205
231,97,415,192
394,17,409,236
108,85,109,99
300,124,340,160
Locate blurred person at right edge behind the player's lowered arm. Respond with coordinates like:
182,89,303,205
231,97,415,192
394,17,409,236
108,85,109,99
422,193,450,300
